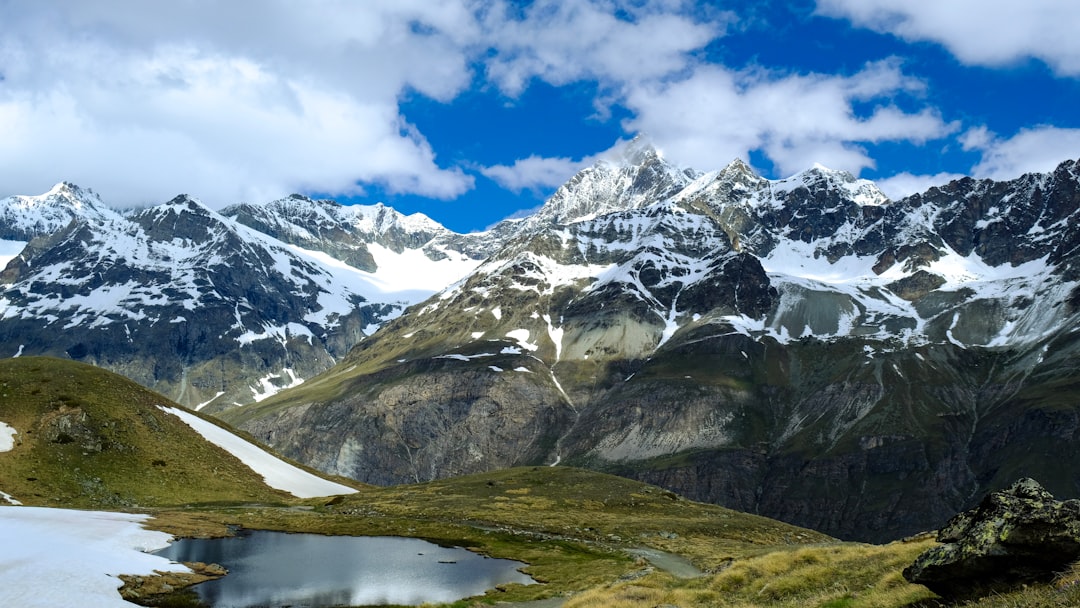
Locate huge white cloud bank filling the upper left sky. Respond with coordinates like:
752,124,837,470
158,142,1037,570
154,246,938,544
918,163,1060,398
0,0,478,205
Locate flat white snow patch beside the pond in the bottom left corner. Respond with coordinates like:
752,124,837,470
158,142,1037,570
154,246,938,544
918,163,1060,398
0,506,188,608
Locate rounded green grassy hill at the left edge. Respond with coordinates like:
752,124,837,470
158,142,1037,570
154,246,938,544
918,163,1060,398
0,357,291,509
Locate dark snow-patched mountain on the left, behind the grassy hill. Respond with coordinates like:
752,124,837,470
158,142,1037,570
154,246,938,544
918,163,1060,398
0,184,478,410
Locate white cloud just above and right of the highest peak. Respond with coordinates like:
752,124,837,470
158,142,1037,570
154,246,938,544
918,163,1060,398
625,62,956,174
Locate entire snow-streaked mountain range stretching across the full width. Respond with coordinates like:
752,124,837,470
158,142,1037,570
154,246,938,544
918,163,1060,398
0,141,1080,540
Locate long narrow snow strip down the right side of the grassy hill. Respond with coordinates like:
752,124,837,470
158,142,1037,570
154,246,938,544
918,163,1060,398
158,406,356,498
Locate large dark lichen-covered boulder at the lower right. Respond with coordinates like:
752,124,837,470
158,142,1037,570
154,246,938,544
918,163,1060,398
904,478,1080,598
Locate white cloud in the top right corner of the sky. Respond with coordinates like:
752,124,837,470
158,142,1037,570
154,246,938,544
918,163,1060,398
818,0,1080,76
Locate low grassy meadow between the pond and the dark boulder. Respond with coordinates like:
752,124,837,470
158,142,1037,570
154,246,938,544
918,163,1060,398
145,468,1080,608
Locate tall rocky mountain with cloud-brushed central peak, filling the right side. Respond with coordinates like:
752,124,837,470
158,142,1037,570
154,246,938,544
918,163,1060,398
226,151,1080,540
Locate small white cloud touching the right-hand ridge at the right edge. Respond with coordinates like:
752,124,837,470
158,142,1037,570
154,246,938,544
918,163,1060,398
961,126,1080,179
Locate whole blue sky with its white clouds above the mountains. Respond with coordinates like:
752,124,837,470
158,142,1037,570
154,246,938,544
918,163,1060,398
0,0,1080,231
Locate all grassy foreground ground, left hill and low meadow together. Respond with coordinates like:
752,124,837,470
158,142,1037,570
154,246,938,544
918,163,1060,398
0,359,1080,608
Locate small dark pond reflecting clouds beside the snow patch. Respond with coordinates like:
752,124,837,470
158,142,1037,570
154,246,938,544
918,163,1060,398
156,530,536,608
